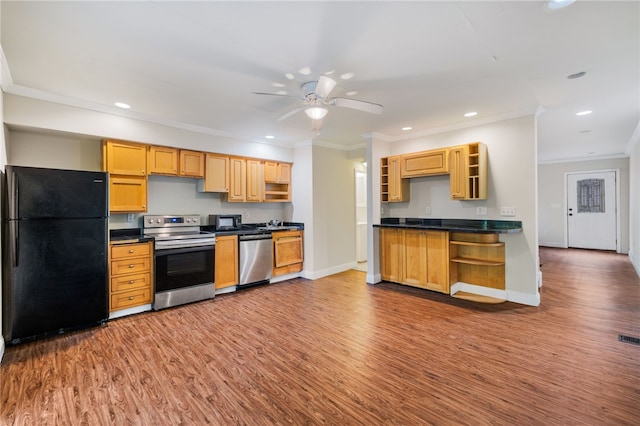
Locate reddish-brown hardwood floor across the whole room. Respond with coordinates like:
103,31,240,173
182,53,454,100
0,248,640,425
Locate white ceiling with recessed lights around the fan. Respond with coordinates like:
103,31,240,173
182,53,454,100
1,0,640,162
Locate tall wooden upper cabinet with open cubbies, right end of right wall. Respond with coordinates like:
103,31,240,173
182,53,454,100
449,142,487,200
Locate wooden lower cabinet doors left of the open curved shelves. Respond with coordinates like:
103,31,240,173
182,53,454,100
380,228,449,294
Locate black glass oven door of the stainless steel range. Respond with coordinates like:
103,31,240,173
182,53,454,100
155,245,215,293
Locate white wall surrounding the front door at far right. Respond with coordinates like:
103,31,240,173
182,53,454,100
538,158,630,253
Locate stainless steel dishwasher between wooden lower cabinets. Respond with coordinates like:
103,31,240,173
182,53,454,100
238,233,272,286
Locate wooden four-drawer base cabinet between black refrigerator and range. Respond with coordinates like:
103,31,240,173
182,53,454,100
109,242,153,312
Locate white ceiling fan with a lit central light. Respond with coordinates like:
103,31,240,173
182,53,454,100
253,75,382,130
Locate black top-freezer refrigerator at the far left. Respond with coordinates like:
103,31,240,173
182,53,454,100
2,166,109,344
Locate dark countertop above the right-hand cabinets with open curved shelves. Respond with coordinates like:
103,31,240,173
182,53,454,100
373,217,522,234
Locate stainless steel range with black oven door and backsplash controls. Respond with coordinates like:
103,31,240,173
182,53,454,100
143,215,216,310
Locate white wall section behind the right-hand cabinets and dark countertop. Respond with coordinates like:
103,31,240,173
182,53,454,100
371,115,539,305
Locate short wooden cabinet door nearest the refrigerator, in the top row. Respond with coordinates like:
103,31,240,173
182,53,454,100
102,140,147,176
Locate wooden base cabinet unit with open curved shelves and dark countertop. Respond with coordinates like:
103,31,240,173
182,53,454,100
373,218,522,303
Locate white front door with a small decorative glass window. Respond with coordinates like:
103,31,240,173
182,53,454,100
567,171,618,250
